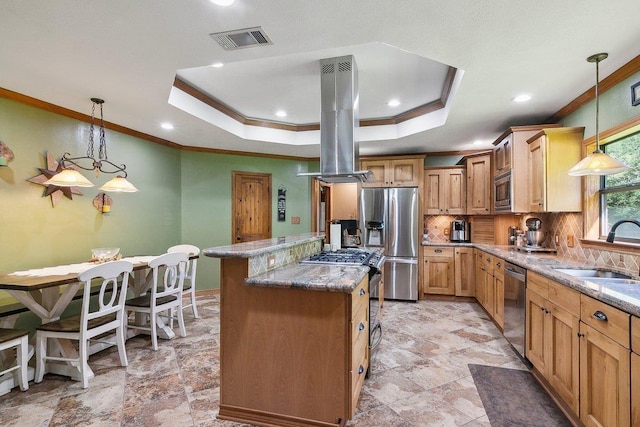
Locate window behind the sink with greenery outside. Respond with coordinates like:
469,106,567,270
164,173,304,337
600,132,640,244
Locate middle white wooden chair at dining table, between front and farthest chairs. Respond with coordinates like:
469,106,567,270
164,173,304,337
125,252,189,350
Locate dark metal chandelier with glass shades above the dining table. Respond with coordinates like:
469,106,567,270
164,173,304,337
44,98,138,193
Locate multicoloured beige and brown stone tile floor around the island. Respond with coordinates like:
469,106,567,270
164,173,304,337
0,295,526,427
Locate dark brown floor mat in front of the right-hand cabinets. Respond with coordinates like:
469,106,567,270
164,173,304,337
468,364,571,427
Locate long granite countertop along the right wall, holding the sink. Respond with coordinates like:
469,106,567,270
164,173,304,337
422,242,640,317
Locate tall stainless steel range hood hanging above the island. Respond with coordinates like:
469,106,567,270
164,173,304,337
298,55,370,183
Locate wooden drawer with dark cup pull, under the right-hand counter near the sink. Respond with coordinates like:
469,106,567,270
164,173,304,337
580,294,631,348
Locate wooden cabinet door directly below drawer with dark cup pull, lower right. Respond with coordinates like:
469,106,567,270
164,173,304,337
580,322,631,427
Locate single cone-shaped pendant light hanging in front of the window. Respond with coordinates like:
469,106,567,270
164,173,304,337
569,53,630,176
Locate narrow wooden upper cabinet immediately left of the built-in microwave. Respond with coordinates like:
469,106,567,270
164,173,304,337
467,154,493,215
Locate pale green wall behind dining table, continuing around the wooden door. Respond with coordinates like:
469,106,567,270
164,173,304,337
0,98,311,301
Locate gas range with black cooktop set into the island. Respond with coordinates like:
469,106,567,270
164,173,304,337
300,248,385,362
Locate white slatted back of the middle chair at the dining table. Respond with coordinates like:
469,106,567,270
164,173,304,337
149,252,189,300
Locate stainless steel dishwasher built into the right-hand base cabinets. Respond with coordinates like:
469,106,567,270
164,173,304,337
504,262,527,357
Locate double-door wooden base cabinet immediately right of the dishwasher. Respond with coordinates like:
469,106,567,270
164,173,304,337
525,272,580,413
